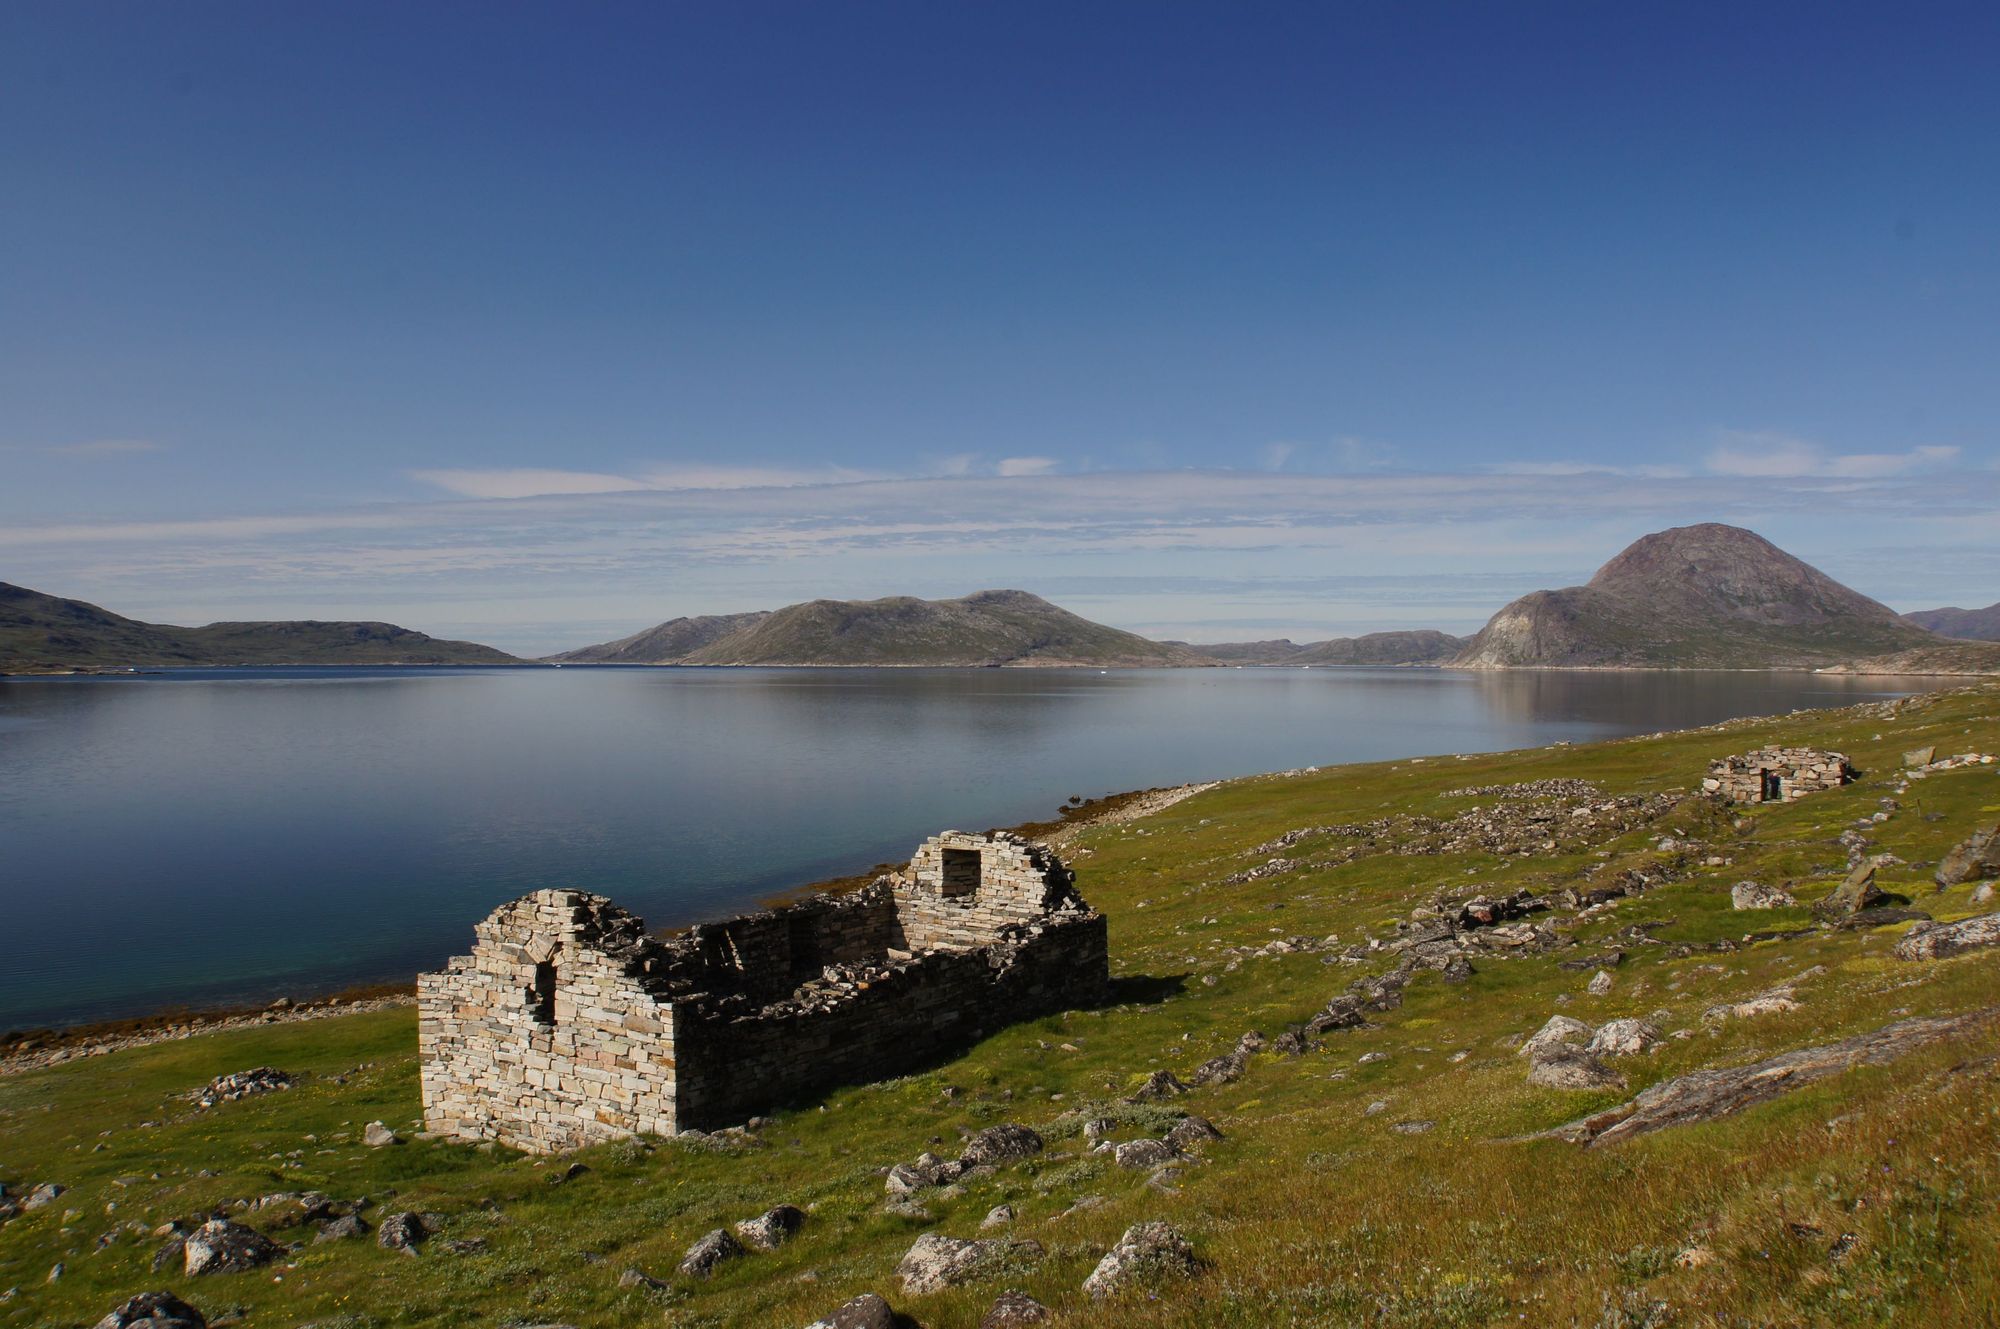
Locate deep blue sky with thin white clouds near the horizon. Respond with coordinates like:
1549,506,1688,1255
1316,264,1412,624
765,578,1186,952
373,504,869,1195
0,0,2000,650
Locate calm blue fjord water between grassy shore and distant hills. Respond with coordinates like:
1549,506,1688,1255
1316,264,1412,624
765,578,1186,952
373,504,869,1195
0,669,1926,1029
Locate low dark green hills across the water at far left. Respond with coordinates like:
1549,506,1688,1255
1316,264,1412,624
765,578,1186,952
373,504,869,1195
0,582,516,673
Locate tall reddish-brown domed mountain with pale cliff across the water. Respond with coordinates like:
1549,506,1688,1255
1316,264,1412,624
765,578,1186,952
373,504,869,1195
1452,522,1978,673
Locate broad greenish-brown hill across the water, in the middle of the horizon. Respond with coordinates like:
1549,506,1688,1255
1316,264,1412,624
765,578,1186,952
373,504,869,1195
552,590,1208,667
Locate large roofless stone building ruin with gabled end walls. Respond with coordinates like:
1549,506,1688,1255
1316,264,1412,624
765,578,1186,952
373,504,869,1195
416,831,1110,1153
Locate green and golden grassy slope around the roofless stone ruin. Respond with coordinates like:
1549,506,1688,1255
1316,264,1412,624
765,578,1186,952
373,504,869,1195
0,691,2000,1329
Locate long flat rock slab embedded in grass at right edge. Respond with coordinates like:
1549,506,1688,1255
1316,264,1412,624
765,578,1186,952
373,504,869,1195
1544,1007,2000,1145
